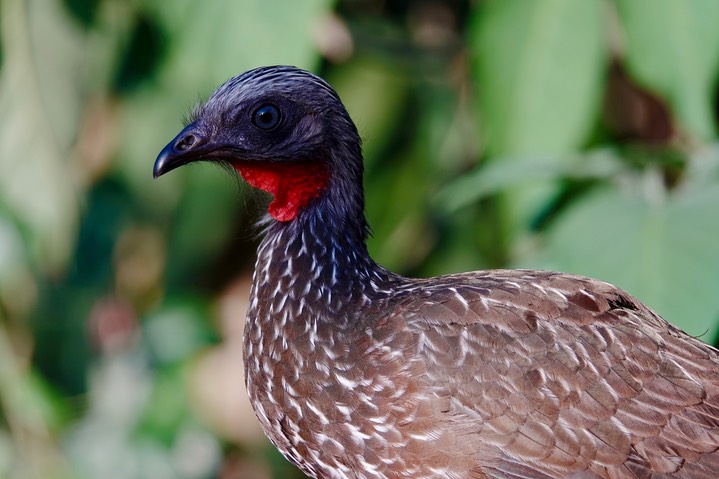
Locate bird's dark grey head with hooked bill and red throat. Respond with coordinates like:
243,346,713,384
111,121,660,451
153,66,362,222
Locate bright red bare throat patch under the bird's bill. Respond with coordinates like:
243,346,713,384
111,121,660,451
233,162,330,221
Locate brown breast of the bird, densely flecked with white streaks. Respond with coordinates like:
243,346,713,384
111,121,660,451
244,272,480,479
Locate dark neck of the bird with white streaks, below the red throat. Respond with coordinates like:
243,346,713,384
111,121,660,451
255,145,399,318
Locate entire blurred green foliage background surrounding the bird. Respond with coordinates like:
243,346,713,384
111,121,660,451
0,0,719,479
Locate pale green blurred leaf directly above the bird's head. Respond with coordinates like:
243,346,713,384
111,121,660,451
155,0,332,96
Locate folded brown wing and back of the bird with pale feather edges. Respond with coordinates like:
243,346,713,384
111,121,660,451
406,271,719,479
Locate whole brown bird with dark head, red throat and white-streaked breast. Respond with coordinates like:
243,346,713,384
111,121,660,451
153,66,719,479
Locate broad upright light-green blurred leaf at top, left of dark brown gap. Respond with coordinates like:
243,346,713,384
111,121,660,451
470,0,606,154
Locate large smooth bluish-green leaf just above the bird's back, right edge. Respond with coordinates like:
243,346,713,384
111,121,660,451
522,176,719,335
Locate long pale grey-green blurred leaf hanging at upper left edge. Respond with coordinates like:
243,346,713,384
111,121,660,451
0,2,84,271
